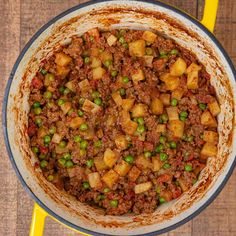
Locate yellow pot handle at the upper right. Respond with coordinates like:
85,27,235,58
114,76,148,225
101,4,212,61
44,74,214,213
201,0,219,32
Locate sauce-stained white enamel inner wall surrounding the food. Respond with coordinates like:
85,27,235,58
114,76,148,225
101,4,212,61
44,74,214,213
4,1,236,235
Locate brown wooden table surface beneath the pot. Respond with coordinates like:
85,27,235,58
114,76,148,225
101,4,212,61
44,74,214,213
0,0,236,236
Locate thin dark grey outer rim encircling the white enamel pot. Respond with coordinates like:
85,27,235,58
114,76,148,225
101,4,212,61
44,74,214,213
2,0,236,236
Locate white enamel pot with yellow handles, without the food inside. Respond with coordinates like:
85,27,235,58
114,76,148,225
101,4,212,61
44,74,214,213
3,0,236,236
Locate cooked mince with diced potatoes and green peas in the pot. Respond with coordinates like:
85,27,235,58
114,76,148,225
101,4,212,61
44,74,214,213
28,29,220,215
